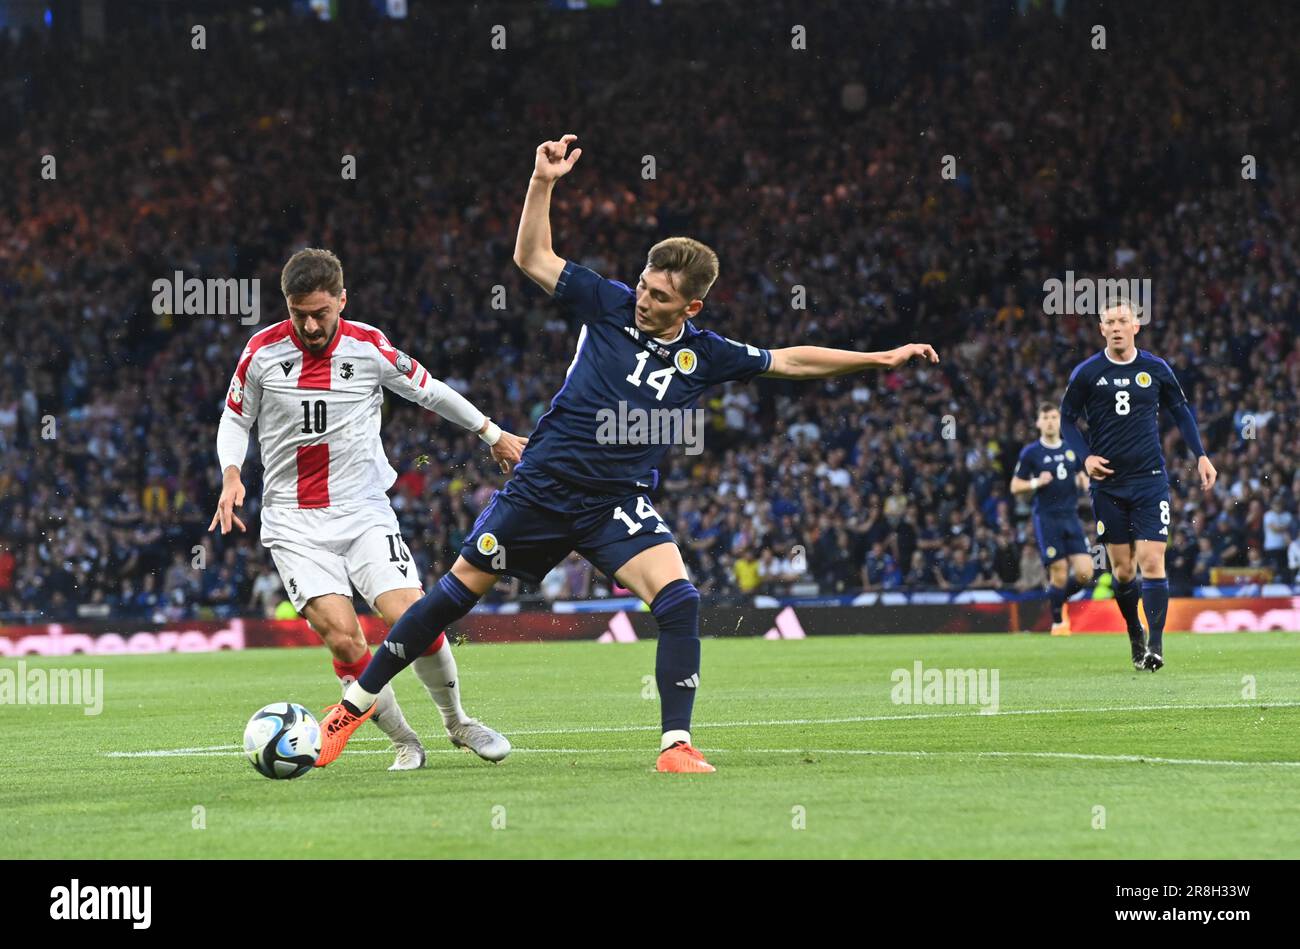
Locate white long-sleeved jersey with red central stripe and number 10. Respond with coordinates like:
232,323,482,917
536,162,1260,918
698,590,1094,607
225,317,485,508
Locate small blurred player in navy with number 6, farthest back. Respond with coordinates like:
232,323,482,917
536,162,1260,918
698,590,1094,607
1011,402,1092,636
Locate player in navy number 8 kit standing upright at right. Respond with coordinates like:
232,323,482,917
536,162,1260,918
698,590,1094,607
1061,300,1217,672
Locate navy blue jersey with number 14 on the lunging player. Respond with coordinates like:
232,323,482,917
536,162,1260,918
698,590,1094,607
519,261,772,495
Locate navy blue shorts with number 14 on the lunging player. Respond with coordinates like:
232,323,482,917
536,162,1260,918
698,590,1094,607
460,469,675,584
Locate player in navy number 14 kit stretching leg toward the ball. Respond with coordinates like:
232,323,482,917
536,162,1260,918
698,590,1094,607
317,135,939,772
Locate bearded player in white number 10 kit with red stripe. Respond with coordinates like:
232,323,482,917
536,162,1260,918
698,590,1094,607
208,248,528,771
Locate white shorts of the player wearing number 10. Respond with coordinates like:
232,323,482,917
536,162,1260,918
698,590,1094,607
261,499,423,612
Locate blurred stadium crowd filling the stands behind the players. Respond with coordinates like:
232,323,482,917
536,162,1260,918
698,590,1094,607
0,0,1300,619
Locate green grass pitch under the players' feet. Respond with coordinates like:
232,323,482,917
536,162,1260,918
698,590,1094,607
0,633,1300,858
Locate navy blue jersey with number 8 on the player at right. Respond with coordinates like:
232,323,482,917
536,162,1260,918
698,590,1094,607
1061,350,1187,489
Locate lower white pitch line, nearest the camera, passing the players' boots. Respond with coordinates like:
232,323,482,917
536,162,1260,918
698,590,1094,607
107,748,1300,768
